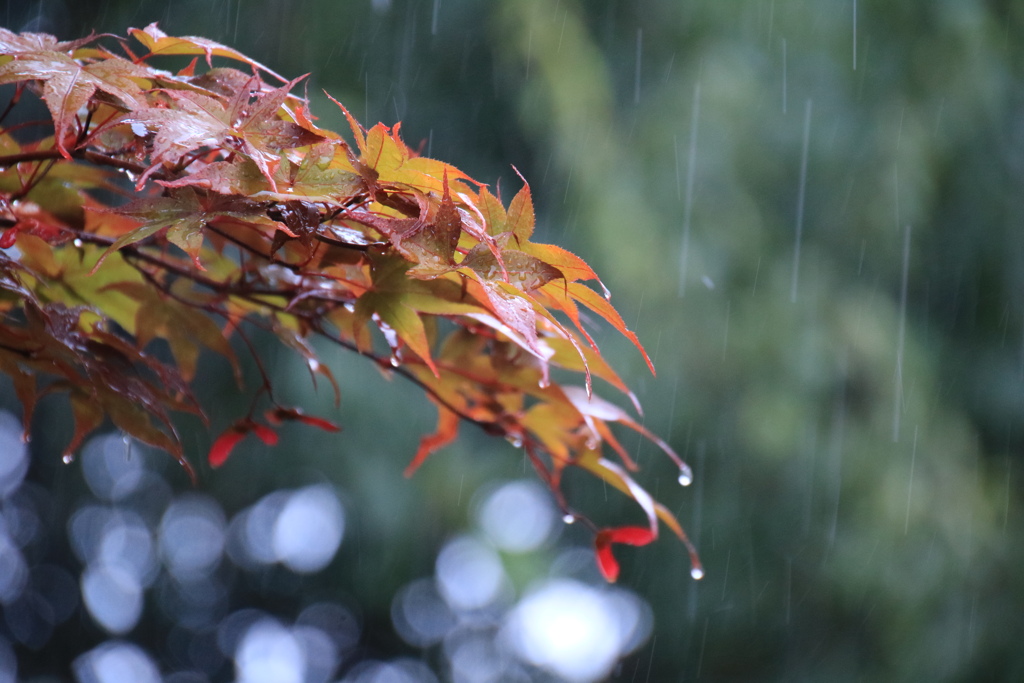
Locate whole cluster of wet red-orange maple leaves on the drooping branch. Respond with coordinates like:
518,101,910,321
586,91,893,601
0,25,701,581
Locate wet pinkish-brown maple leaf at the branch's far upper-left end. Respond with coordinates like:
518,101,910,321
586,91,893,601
0,51,152,159
